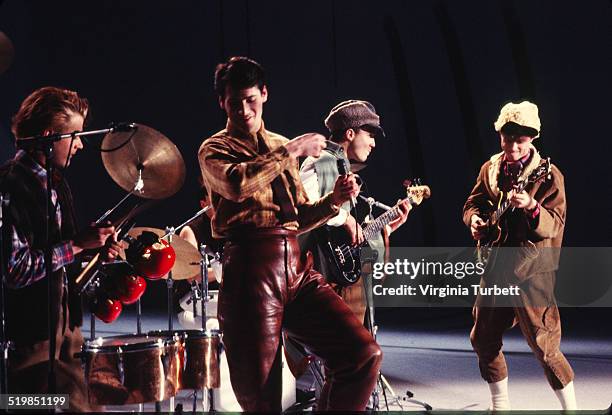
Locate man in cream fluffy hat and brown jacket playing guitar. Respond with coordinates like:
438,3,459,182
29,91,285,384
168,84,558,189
463,101,576,410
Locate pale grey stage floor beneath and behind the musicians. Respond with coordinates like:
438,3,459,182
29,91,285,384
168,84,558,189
83,309,612,410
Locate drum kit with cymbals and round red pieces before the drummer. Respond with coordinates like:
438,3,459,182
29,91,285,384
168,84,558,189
75,124,227,411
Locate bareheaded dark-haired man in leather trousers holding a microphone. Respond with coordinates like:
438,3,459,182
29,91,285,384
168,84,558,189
199,57,382,411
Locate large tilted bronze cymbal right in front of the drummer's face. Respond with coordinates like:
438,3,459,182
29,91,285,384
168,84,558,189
102,124,185,199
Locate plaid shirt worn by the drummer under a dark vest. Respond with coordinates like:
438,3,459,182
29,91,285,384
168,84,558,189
6,150,74,288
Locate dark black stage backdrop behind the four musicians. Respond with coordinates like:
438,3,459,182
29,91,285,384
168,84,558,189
0,0,612,314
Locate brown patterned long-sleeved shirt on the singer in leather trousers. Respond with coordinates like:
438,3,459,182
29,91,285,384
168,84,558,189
199,121,338,238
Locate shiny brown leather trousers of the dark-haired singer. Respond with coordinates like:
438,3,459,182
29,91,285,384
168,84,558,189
219,228,382,411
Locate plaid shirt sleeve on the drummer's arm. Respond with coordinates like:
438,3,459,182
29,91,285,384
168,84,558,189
6,226,74,288
